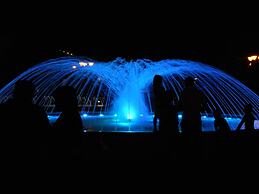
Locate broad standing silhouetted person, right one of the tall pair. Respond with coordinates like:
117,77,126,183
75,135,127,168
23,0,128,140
179,77,206,134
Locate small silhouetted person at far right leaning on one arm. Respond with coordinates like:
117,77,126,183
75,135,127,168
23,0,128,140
236,104,255,132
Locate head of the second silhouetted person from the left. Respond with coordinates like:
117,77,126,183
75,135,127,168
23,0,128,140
54,86,77,111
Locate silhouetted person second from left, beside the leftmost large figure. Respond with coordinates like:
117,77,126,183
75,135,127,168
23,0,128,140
53,86,83,158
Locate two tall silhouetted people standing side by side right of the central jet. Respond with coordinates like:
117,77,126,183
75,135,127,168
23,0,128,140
153,75,206,134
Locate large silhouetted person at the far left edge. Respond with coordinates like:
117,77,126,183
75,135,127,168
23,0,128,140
1,80,50,160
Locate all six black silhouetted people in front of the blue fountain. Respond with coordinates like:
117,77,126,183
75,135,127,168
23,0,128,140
0,75,255,160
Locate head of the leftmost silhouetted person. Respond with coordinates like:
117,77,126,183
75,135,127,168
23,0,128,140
13,80,35,102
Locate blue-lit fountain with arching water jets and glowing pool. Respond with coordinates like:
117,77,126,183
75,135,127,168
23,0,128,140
0,57,259,131
